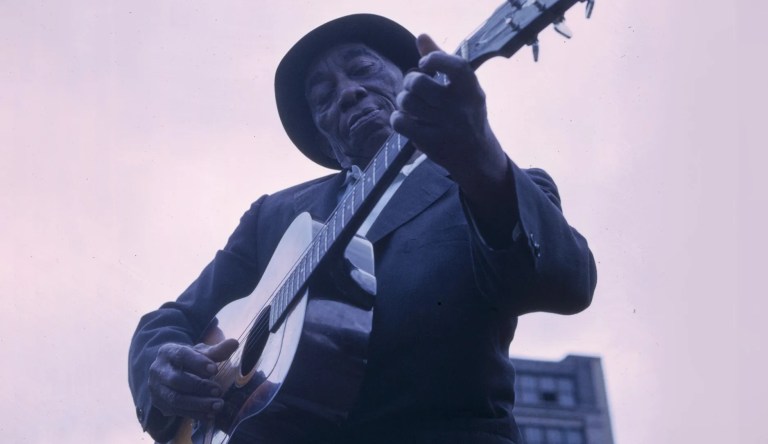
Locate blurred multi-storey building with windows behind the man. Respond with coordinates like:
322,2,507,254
511,355,613,444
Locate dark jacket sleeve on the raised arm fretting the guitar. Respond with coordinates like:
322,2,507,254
463,160,597,315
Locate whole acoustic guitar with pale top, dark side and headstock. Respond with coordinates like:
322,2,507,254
170,0,594,444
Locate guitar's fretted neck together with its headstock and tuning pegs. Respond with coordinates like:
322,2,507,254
269,0,594,331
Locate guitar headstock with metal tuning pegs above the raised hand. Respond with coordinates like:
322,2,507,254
457,0,595,69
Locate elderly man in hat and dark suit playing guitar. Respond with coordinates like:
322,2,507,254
129,14,596,444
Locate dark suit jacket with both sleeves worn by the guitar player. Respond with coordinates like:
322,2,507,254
129,160,596,443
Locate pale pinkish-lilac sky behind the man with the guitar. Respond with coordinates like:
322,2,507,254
0,0,768,444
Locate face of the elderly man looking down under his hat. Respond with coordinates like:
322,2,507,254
305,43,403,168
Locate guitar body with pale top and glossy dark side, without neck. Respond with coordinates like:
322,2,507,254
171,213,373,444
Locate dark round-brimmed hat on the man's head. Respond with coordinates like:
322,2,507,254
275,14,419,170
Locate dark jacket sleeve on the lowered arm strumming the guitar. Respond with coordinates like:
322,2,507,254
128,197,264,442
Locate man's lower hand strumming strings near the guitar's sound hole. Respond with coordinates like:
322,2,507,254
149,339,238,419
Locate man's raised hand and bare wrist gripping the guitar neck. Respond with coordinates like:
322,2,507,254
390,34,518,247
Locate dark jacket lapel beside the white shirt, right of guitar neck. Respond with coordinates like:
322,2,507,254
366,159,455,243
